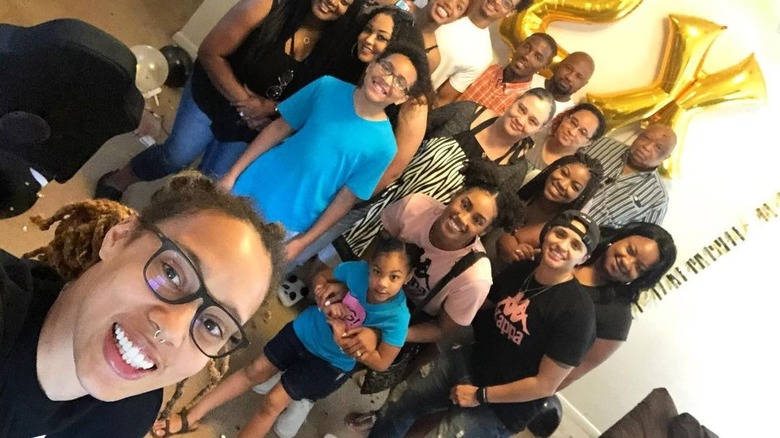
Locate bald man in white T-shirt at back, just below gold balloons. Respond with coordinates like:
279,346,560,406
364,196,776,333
544,52,596,115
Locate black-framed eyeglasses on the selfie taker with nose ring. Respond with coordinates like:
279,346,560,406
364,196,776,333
141,221,249,359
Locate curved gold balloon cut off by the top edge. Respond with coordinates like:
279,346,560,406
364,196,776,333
498,0,642,67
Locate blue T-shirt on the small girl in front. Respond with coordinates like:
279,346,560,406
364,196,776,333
293,262,409,371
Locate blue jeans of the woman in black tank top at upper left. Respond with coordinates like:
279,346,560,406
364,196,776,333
130,82,247,181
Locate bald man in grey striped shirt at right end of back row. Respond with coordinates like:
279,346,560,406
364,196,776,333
583,124,677,228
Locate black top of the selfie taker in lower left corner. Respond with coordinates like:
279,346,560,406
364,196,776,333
0,250,163,438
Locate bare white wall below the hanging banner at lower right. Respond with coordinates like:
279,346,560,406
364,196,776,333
564,222,780,438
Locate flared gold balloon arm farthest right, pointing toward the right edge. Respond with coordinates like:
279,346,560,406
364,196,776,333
643,54,766,178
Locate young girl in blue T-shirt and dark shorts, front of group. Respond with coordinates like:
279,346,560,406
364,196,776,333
154,237,417,438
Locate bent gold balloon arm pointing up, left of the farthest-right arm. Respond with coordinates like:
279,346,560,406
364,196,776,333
587,15,725,132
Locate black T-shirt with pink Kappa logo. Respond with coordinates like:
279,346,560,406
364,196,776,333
472,262,596,431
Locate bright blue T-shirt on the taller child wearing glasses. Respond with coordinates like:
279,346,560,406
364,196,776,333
233,76,396,232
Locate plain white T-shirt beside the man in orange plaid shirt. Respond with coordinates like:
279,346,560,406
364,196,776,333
431,17,493,93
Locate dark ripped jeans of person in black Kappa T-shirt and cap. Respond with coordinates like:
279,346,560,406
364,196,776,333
368,347,512,438
